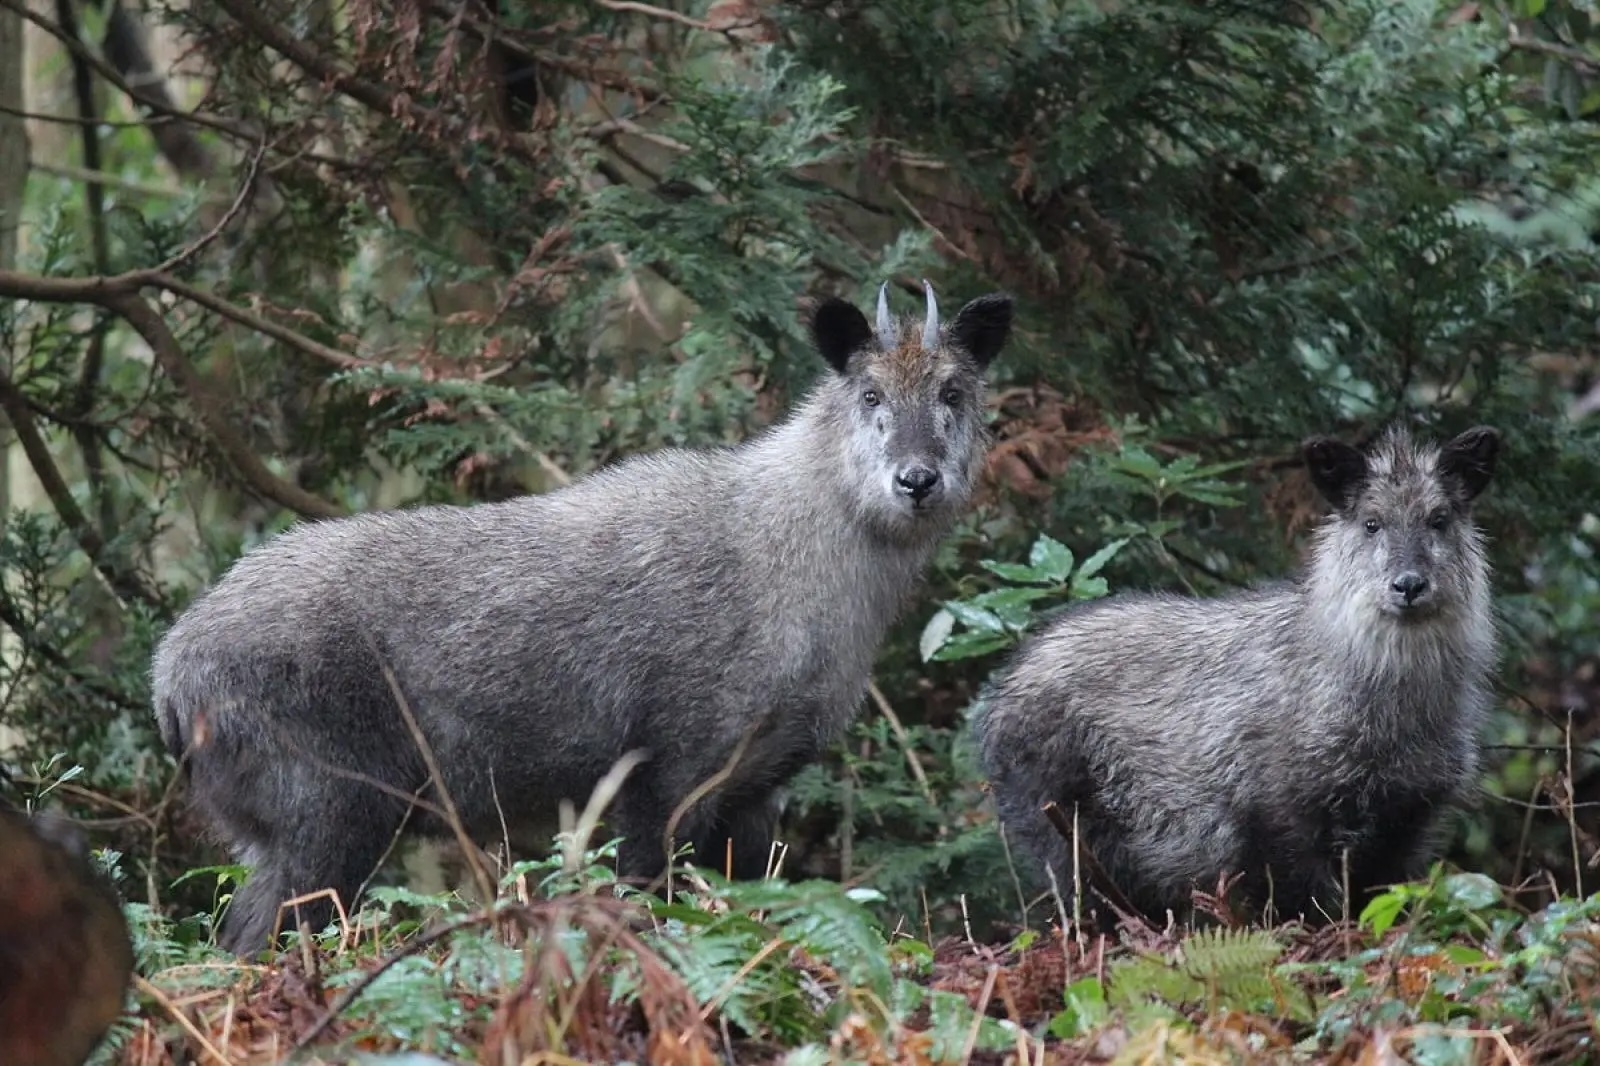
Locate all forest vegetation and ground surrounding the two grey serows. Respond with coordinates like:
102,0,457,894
0,0,1600,1066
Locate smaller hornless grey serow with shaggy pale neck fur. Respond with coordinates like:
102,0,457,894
973,427,1499,922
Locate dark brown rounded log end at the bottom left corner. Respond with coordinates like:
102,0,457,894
0,805,133,1066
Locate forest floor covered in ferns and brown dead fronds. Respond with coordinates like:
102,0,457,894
98,866,1600,1066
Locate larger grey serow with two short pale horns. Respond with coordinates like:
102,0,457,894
154,283,1011,954
